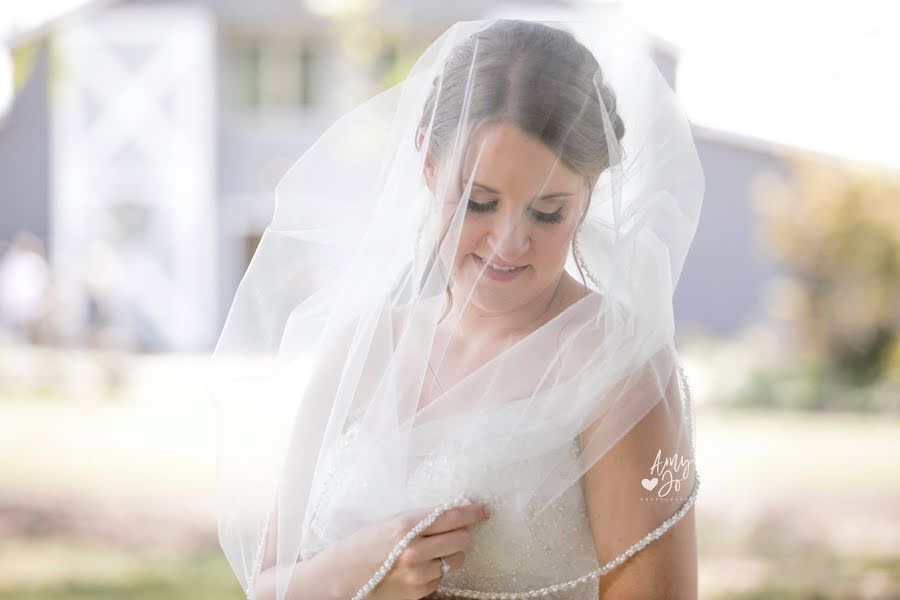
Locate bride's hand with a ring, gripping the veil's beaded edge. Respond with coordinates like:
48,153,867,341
347,503,489,600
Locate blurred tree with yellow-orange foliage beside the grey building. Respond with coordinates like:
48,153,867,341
752,154,900,385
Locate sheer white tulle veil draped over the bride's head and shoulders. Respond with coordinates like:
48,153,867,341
213,15,704,598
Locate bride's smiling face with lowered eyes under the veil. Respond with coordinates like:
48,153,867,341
428,123,588,312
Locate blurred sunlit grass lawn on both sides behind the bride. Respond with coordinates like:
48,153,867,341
0,382,900,600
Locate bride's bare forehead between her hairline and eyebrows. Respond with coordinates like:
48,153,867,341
463,122,582,195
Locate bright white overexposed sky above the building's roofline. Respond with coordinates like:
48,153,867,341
0,0,900,169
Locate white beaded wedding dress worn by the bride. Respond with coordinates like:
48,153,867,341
301,412,599,600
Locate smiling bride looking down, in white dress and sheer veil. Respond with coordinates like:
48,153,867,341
214,14,704,600
